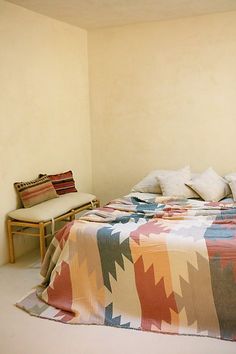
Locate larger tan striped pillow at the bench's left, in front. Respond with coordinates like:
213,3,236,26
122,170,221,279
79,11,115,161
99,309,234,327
14,175,58,208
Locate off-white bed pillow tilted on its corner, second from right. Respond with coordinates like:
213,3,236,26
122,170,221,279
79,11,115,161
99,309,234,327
186,167,230,202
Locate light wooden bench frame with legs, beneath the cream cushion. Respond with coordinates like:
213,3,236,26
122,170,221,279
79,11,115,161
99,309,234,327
7,199,100,263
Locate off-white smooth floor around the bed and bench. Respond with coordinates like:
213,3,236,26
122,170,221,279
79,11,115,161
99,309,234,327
0,253,236,354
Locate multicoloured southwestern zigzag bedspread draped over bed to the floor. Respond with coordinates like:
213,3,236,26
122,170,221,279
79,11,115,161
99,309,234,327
17,197,236,340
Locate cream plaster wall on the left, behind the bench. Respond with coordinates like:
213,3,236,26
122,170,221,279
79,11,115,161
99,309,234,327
0,1,92,264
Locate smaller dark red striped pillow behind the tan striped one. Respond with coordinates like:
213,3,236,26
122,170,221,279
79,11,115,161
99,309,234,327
44,171,77,195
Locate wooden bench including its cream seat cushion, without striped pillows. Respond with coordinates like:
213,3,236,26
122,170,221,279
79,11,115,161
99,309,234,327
7,192,99,263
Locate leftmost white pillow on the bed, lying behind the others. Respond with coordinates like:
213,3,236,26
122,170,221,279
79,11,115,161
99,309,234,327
132,166,194,194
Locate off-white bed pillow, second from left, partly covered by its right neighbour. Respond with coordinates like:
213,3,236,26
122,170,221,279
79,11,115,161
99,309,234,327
159,166,199,198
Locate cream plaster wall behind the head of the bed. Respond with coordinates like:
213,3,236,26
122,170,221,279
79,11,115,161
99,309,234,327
88,12,236,201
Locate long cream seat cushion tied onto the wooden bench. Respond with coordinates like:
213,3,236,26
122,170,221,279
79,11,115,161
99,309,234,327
8,192,96,222
